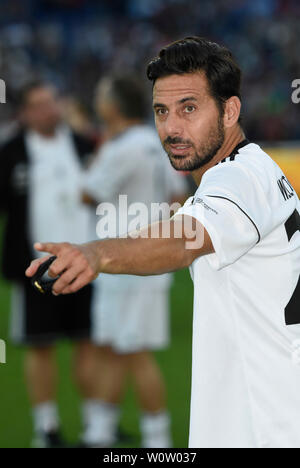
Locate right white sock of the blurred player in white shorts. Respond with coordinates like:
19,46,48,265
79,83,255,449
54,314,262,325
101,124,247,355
141,411,172,448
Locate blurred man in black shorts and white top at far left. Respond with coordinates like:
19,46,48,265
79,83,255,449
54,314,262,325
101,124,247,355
0,81,94,447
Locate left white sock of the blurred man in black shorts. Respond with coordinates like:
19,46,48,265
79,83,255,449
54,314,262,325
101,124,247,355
32,401,59,432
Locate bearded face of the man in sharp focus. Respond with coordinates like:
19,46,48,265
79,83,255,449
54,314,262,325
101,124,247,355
153,72,225,171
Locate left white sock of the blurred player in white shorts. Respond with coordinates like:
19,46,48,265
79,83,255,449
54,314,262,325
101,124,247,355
82,400,120,447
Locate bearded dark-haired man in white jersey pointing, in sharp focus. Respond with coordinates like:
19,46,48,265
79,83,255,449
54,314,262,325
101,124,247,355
27,37,300,448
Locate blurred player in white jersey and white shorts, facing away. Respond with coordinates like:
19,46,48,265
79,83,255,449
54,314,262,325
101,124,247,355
82,74,187,448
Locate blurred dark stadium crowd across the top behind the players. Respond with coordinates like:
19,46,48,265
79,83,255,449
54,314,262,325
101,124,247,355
0,0,300,141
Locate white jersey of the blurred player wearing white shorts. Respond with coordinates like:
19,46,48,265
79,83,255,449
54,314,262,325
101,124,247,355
82,125,187,289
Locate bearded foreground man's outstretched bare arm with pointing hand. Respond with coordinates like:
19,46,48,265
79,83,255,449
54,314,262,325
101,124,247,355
26,216,214,294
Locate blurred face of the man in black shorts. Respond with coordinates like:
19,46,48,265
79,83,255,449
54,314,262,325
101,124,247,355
22,87,62,135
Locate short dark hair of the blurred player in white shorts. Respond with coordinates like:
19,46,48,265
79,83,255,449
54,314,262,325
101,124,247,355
108,74,150,120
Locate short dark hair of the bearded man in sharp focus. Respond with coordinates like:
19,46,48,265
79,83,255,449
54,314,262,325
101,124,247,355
147,36,241,121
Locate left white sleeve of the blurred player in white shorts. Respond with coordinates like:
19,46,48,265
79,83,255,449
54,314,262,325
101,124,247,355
81,145,137,203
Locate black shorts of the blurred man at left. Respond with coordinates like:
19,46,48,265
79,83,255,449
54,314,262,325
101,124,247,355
11,281,92,345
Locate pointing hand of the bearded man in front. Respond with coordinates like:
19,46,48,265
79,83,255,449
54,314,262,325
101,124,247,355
26,242,99,295
